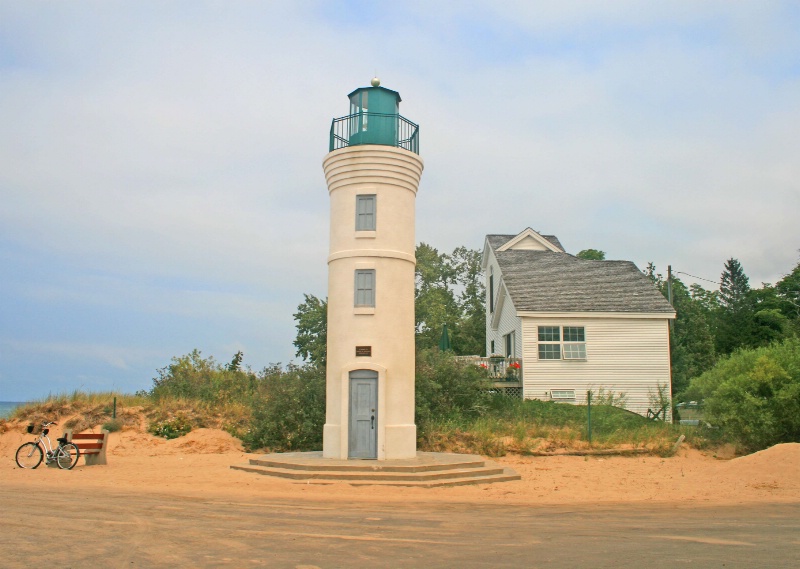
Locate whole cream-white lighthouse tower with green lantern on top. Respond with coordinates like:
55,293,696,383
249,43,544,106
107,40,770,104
322,78,423,460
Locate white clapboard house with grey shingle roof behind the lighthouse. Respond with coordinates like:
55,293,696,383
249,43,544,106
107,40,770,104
482,229,675,415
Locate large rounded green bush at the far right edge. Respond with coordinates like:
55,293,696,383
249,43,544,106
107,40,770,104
686,338,800,452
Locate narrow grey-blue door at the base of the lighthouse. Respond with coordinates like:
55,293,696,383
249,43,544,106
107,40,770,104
347,369,378,459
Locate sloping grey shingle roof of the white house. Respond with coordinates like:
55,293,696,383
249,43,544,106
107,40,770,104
494,247,674,314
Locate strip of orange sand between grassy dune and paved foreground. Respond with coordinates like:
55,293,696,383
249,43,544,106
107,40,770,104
0,423,800,505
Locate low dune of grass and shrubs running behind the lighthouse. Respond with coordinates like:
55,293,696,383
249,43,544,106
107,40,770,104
0,350,714,456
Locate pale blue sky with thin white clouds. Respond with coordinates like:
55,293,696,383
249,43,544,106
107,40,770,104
0,0,800,401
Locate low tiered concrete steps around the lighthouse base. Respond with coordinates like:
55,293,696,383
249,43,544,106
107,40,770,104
231,452,520,488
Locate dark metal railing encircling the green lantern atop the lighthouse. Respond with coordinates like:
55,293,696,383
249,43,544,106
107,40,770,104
330,113,419,154
